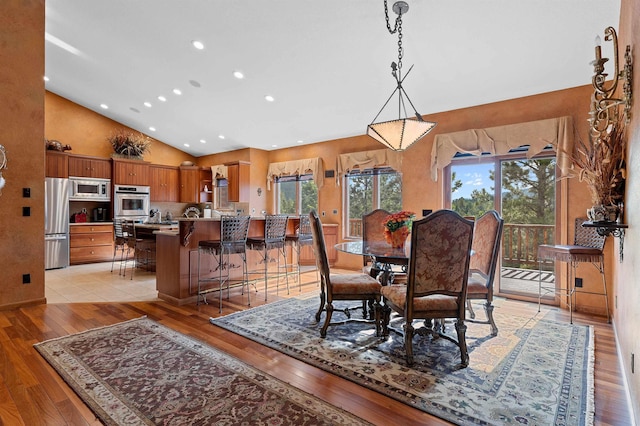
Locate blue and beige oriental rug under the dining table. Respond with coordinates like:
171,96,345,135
210,298,594,425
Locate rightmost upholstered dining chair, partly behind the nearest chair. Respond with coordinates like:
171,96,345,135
467,210,504,336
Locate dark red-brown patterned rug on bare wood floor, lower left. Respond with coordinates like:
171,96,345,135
35,318,368,425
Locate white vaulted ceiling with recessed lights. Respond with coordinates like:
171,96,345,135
45,0,620,156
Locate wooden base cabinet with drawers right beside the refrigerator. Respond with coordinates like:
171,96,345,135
69,223,113,265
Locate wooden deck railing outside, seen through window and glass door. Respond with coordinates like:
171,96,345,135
349,219,555,269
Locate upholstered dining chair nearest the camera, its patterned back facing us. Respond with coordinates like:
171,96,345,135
381,210,473,367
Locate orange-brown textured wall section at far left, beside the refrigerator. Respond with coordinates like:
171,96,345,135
0,0,44,308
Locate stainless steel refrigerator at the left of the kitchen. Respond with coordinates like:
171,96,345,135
44,178,69,269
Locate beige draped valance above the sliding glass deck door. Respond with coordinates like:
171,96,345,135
431,116,573,181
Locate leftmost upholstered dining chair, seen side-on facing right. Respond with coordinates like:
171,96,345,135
309,210,382,337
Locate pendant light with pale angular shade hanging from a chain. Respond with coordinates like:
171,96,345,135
367,0,436,151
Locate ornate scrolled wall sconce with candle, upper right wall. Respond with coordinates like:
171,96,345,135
589,27,633,140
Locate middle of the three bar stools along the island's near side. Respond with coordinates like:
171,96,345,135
247,214,289,301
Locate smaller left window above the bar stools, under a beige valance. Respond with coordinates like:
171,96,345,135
276,175,318,215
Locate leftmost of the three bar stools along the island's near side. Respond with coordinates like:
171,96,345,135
196,216,251,313
